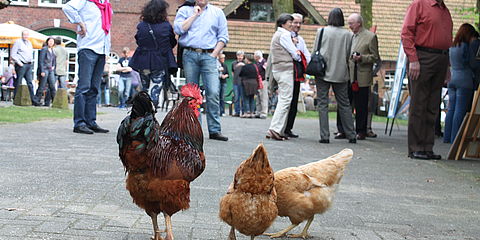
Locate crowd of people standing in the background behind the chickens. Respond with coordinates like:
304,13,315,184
2,0,480,159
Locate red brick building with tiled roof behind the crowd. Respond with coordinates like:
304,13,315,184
0,0,475,86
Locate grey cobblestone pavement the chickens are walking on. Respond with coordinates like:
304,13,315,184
0,105,480,240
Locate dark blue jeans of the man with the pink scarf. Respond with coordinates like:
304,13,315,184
73,49,105,127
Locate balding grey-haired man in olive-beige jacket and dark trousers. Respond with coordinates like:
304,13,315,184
347,13,380,140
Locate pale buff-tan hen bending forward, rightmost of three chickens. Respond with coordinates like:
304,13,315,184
265,149,353,239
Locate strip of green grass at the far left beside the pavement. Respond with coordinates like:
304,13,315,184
0,106,73,123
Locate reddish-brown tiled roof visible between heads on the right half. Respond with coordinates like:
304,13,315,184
209,0,476,61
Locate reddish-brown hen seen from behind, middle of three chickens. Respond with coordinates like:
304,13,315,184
219,144,278,240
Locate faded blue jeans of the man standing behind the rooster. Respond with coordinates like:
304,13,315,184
183,50,222,134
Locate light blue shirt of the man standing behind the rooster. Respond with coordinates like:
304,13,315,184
173,4,228,49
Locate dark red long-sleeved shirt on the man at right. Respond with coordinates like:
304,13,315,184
402,0,453,62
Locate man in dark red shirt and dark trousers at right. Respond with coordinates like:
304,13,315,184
402,0,453,160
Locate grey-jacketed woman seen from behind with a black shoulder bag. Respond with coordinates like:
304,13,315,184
313,8,357,143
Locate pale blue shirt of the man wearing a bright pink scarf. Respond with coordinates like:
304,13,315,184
62,0,111,55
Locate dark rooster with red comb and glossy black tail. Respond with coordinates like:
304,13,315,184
117,84,205,240
